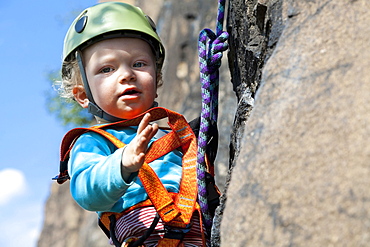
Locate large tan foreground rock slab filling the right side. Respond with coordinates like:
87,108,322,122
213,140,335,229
221,0,370,246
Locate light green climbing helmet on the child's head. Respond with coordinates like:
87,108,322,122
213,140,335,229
63,2,165,67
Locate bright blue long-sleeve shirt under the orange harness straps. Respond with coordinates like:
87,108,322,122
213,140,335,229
68,127,182,217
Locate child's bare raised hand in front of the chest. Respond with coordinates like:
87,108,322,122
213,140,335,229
121,113,158,181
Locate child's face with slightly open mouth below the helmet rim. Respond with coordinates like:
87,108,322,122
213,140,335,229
79,38,157,119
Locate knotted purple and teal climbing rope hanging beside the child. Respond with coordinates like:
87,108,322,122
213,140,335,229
197,0,229,233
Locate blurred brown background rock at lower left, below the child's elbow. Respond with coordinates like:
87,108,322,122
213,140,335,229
37,182,109,247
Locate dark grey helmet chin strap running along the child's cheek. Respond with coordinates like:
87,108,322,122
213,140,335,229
75,51,124,122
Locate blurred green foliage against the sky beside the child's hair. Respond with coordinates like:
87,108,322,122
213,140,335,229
46,71,93,127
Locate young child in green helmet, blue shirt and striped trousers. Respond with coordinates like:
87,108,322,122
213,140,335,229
62,2,205,246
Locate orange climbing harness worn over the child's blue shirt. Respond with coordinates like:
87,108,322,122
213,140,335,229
56,107,218,247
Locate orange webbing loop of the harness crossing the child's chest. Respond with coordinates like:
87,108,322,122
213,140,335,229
106,107,198,227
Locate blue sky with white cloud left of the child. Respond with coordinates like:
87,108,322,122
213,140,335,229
0,0,97,247
